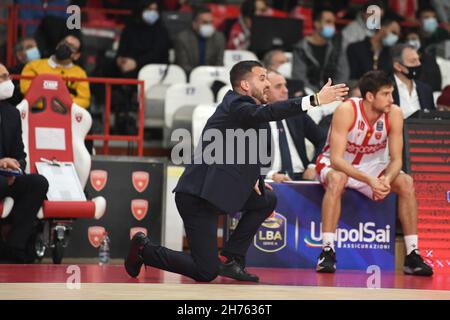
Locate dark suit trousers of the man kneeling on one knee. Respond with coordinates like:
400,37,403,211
143,189,276,282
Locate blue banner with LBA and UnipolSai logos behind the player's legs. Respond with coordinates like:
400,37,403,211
229,183,396,270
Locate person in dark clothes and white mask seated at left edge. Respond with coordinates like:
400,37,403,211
0,64,48,263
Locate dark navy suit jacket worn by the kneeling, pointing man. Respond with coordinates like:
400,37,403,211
174,90,304,213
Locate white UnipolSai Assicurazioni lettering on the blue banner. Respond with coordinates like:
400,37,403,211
304,221,391,250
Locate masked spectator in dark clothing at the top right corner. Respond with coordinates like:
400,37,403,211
418,6,450,55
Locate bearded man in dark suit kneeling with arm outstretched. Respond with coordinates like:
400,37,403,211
125,61,348,282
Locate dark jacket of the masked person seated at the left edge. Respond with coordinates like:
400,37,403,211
0,101,26,171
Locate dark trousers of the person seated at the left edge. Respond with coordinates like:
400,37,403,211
0,174,48,250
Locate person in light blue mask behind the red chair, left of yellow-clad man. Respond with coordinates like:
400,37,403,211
8,37,41,106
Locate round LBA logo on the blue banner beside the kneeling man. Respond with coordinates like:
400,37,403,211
254,211,287,252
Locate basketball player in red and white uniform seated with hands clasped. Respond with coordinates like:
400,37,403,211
316,71,433,276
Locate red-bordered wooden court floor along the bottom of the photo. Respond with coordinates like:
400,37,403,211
0,264,450,300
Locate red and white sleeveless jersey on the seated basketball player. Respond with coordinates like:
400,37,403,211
317,98,389,172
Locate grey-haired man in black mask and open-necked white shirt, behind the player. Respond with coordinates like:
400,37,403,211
392,44,435,119
